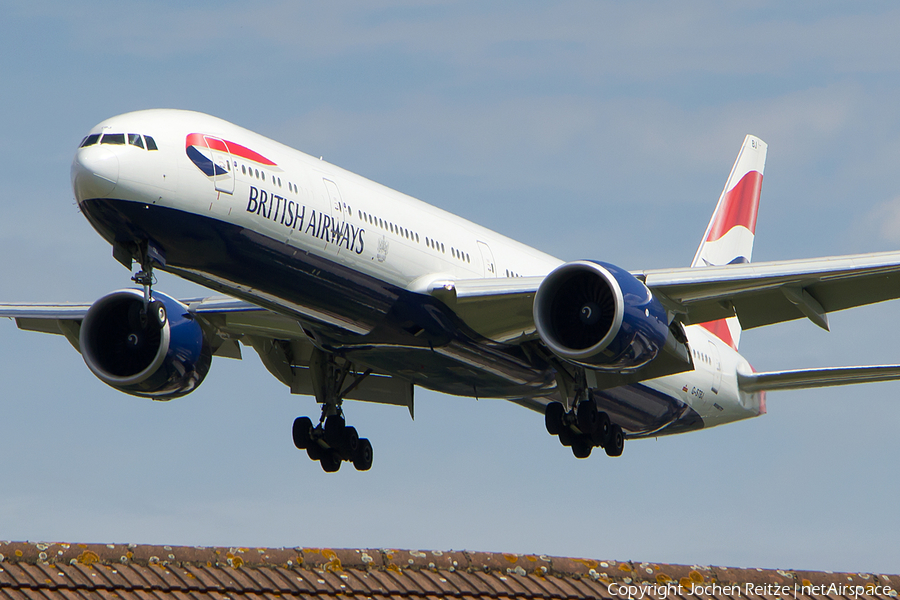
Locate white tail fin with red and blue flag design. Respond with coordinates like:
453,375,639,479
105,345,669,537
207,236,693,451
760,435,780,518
691,135,768,349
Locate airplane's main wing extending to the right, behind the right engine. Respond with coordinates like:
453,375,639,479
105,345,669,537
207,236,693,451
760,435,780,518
430,252,900,342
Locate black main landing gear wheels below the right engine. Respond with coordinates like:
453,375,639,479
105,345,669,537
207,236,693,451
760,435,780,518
544,400,625,458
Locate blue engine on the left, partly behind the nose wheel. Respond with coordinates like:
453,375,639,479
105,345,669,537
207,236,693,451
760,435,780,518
79,289,212,400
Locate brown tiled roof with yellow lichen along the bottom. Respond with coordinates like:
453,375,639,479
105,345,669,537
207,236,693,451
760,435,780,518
0,542,900,600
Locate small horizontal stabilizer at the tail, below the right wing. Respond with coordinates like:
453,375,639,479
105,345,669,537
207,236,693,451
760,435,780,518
737,365,900,393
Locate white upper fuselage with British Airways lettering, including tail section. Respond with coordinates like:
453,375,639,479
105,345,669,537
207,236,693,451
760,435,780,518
73,110,765,435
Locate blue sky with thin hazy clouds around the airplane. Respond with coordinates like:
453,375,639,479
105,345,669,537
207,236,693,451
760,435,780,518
0,0,900,573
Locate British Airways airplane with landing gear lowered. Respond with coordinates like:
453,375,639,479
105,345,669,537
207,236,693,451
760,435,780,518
0,109,900,472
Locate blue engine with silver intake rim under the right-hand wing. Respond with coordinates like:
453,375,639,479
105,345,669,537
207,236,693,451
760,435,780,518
534,260,669,370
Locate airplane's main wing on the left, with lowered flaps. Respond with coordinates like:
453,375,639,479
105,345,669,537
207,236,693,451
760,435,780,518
0,296,413,414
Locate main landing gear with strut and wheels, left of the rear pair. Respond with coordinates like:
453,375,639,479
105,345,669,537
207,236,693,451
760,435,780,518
291,350,372,473
